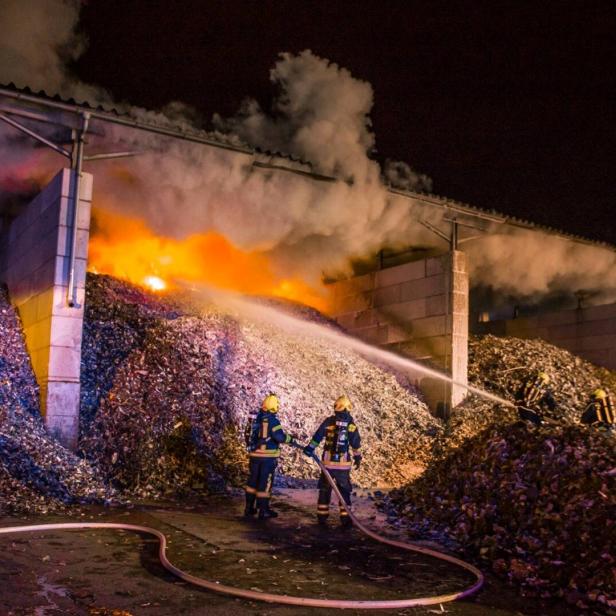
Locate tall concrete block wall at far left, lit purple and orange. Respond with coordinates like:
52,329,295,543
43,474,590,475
0,169,92,447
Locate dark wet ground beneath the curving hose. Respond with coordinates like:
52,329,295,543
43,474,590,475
0,489,588,616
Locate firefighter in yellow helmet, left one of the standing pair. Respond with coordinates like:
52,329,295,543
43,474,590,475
244,394,294,520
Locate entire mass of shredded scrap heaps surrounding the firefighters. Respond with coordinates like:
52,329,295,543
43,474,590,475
0,274,616,609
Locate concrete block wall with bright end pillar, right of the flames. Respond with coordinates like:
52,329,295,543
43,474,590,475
332,251,468,409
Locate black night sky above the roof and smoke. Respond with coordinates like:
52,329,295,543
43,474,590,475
75,0,616,243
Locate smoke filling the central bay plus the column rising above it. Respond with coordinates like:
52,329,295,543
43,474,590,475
72,51,434,282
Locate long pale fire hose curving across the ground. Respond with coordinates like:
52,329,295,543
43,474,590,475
0,454,483,609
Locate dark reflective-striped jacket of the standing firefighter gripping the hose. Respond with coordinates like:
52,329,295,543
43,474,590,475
306,411,361,470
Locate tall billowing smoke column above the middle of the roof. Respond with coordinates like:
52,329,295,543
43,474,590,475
217,50,380,183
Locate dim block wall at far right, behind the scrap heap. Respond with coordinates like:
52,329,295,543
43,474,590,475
473,304,616,370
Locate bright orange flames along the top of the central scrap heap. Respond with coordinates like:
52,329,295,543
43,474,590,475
88,208,327,311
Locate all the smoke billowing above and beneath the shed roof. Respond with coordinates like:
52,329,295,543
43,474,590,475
0,0,616,304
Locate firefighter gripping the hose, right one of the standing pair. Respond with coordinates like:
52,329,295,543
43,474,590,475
304,395,361,527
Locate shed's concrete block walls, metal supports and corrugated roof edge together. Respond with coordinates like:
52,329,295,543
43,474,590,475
0,85,616,447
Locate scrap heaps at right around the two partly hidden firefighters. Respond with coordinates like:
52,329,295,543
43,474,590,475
393,336,616,607
